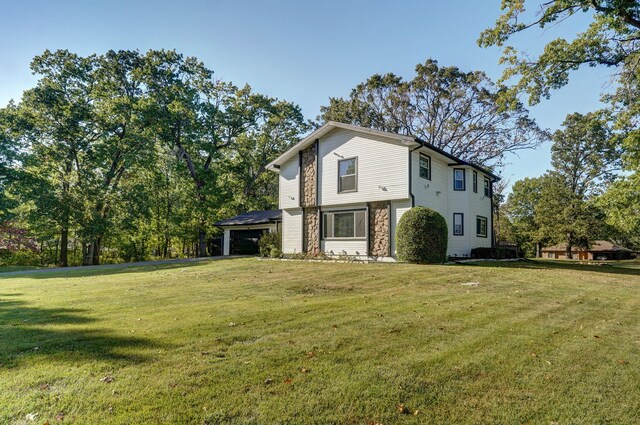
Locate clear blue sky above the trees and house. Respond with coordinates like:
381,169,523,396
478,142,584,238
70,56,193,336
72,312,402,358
0,0,611,189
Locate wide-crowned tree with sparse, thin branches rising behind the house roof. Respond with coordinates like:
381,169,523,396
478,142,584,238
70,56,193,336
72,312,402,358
318,59,546,166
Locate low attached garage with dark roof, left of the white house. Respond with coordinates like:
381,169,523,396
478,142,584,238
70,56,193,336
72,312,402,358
215,210,282,255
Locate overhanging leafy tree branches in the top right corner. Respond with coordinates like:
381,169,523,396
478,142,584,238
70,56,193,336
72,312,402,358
478,0,640,104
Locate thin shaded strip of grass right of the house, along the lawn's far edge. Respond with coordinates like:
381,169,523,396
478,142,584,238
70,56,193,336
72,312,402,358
467,260,640,276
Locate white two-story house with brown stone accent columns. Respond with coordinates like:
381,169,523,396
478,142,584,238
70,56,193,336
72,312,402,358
267,122,498,258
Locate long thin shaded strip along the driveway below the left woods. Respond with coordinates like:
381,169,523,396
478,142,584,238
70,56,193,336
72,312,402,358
0,257,249,280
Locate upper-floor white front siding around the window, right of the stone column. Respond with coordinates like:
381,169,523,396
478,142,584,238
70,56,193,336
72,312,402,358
318,129,409,206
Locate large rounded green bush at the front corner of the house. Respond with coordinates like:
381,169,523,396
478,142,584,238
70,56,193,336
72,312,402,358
396,207,448,264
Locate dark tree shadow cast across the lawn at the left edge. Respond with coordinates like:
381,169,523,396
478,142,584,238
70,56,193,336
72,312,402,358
0,295,167,367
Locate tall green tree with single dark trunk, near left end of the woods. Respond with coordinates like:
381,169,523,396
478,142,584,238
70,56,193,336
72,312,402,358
21,50,100,267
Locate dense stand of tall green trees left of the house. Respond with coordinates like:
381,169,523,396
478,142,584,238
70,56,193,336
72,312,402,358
0,50,308,265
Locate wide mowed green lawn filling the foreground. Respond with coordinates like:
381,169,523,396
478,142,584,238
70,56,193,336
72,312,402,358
0,259,640,424
